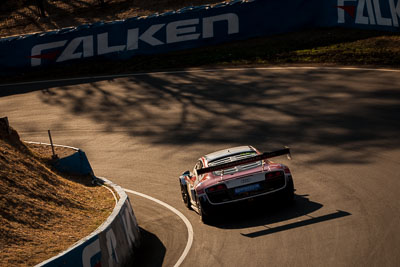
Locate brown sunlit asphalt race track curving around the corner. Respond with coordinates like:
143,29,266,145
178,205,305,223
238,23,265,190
0,68,400,267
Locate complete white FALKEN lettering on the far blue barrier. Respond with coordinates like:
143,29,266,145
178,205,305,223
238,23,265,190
31,12,241,66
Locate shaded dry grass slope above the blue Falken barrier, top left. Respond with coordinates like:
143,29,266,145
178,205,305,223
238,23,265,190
0,0,223,37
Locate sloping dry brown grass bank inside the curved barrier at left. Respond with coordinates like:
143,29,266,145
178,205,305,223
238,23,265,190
0,124,115,266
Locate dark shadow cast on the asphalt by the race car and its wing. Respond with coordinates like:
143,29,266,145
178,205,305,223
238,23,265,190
206,195,351,234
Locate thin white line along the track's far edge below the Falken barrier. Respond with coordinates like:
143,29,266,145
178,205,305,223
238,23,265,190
0,67,400,88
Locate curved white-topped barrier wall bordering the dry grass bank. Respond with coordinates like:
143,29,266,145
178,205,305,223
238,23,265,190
26,142,140,267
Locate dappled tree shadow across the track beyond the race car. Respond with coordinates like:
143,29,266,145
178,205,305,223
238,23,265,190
4,69,400,164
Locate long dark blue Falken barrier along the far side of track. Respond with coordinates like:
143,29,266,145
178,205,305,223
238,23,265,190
0,0,400,72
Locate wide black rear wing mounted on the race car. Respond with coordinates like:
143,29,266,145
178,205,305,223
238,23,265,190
197,147,292,175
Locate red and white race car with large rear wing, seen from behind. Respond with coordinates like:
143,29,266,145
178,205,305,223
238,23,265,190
179,146,294,223
